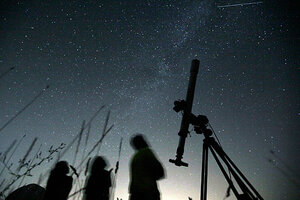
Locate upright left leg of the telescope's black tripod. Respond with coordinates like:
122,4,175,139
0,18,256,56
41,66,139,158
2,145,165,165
200,141,208,200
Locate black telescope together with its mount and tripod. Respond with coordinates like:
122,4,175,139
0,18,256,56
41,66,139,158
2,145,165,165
169,60,263,200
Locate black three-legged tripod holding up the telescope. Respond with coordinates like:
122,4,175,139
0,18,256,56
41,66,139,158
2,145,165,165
200,134,263,200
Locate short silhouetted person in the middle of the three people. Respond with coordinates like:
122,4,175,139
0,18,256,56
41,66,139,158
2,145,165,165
84,156,111,200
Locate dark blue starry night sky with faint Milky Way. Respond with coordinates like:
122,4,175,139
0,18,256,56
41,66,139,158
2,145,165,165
0,0,300,200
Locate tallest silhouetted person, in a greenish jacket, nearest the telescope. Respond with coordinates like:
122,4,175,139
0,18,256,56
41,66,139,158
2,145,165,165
129,134,165,200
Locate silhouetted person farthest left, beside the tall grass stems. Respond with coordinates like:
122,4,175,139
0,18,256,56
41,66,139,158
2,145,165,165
44,161,73,200
